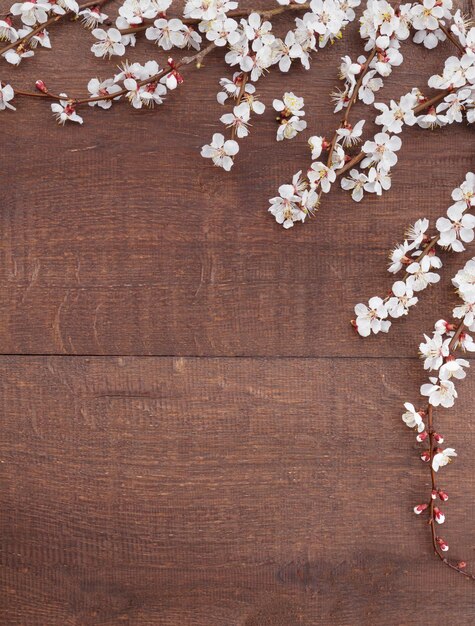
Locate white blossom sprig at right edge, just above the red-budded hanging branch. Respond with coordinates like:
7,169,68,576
352,172,475,337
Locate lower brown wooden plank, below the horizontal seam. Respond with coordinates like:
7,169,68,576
0,357,475,626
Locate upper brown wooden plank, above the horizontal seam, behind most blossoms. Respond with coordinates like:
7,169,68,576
0,3,475,356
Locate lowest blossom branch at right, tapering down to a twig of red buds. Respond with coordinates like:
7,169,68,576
402,258,475,578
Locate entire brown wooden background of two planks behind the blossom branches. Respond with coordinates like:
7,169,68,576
0,0,475,626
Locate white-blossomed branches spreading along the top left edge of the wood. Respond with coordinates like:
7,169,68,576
0,0,360,149
